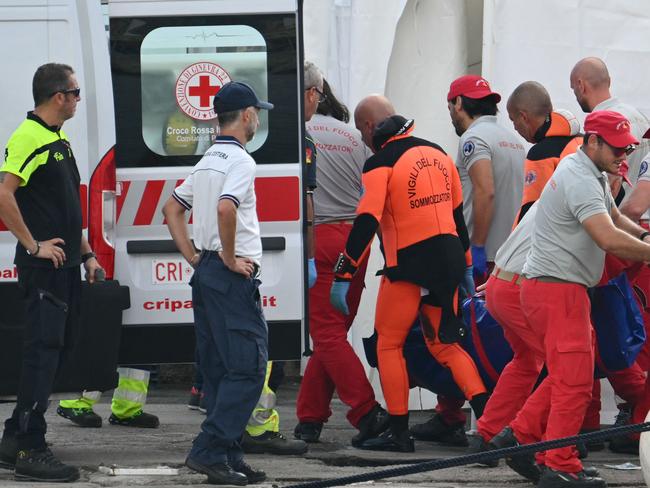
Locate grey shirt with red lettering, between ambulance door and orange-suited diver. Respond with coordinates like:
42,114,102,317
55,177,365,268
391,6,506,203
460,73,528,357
307,114,372,224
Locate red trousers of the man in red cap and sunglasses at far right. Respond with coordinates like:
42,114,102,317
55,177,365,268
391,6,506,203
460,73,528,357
510,279,594,473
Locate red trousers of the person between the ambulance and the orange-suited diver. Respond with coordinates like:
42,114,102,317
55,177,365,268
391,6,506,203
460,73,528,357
296,222,377,427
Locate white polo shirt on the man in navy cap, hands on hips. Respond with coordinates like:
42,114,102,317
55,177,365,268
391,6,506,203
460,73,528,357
173,136,262,265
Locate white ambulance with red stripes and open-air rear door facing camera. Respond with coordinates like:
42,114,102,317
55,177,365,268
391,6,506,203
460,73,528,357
0,0,307,394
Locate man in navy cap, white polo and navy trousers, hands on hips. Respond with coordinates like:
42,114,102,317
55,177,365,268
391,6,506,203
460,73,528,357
163,82,273,485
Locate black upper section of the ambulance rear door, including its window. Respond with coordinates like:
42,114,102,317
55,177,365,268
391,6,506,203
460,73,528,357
110,15,299,167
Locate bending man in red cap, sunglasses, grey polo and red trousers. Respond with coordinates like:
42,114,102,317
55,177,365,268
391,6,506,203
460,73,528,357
490,110,650,488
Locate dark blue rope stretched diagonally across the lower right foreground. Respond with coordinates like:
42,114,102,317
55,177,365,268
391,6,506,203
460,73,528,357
274,422,650,488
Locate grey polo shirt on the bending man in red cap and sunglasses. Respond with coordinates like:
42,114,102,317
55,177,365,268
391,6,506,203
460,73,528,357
523,149,615,287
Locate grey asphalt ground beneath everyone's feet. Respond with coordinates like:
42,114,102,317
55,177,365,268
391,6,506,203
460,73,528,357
0,381,646,488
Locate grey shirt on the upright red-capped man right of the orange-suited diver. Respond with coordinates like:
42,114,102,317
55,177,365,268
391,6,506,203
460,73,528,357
456,115,526,261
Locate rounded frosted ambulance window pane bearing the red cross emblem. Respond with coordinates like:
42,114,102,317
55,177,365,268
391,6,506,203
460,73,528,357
140,25,268,156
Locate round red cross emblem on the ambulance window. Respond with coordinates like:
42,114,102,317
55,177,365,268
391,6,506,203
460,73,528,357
175,62,231,120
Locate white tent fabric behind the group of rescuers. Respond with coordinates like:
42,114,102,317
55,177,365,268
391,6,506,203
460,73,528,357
304,0,650,420
